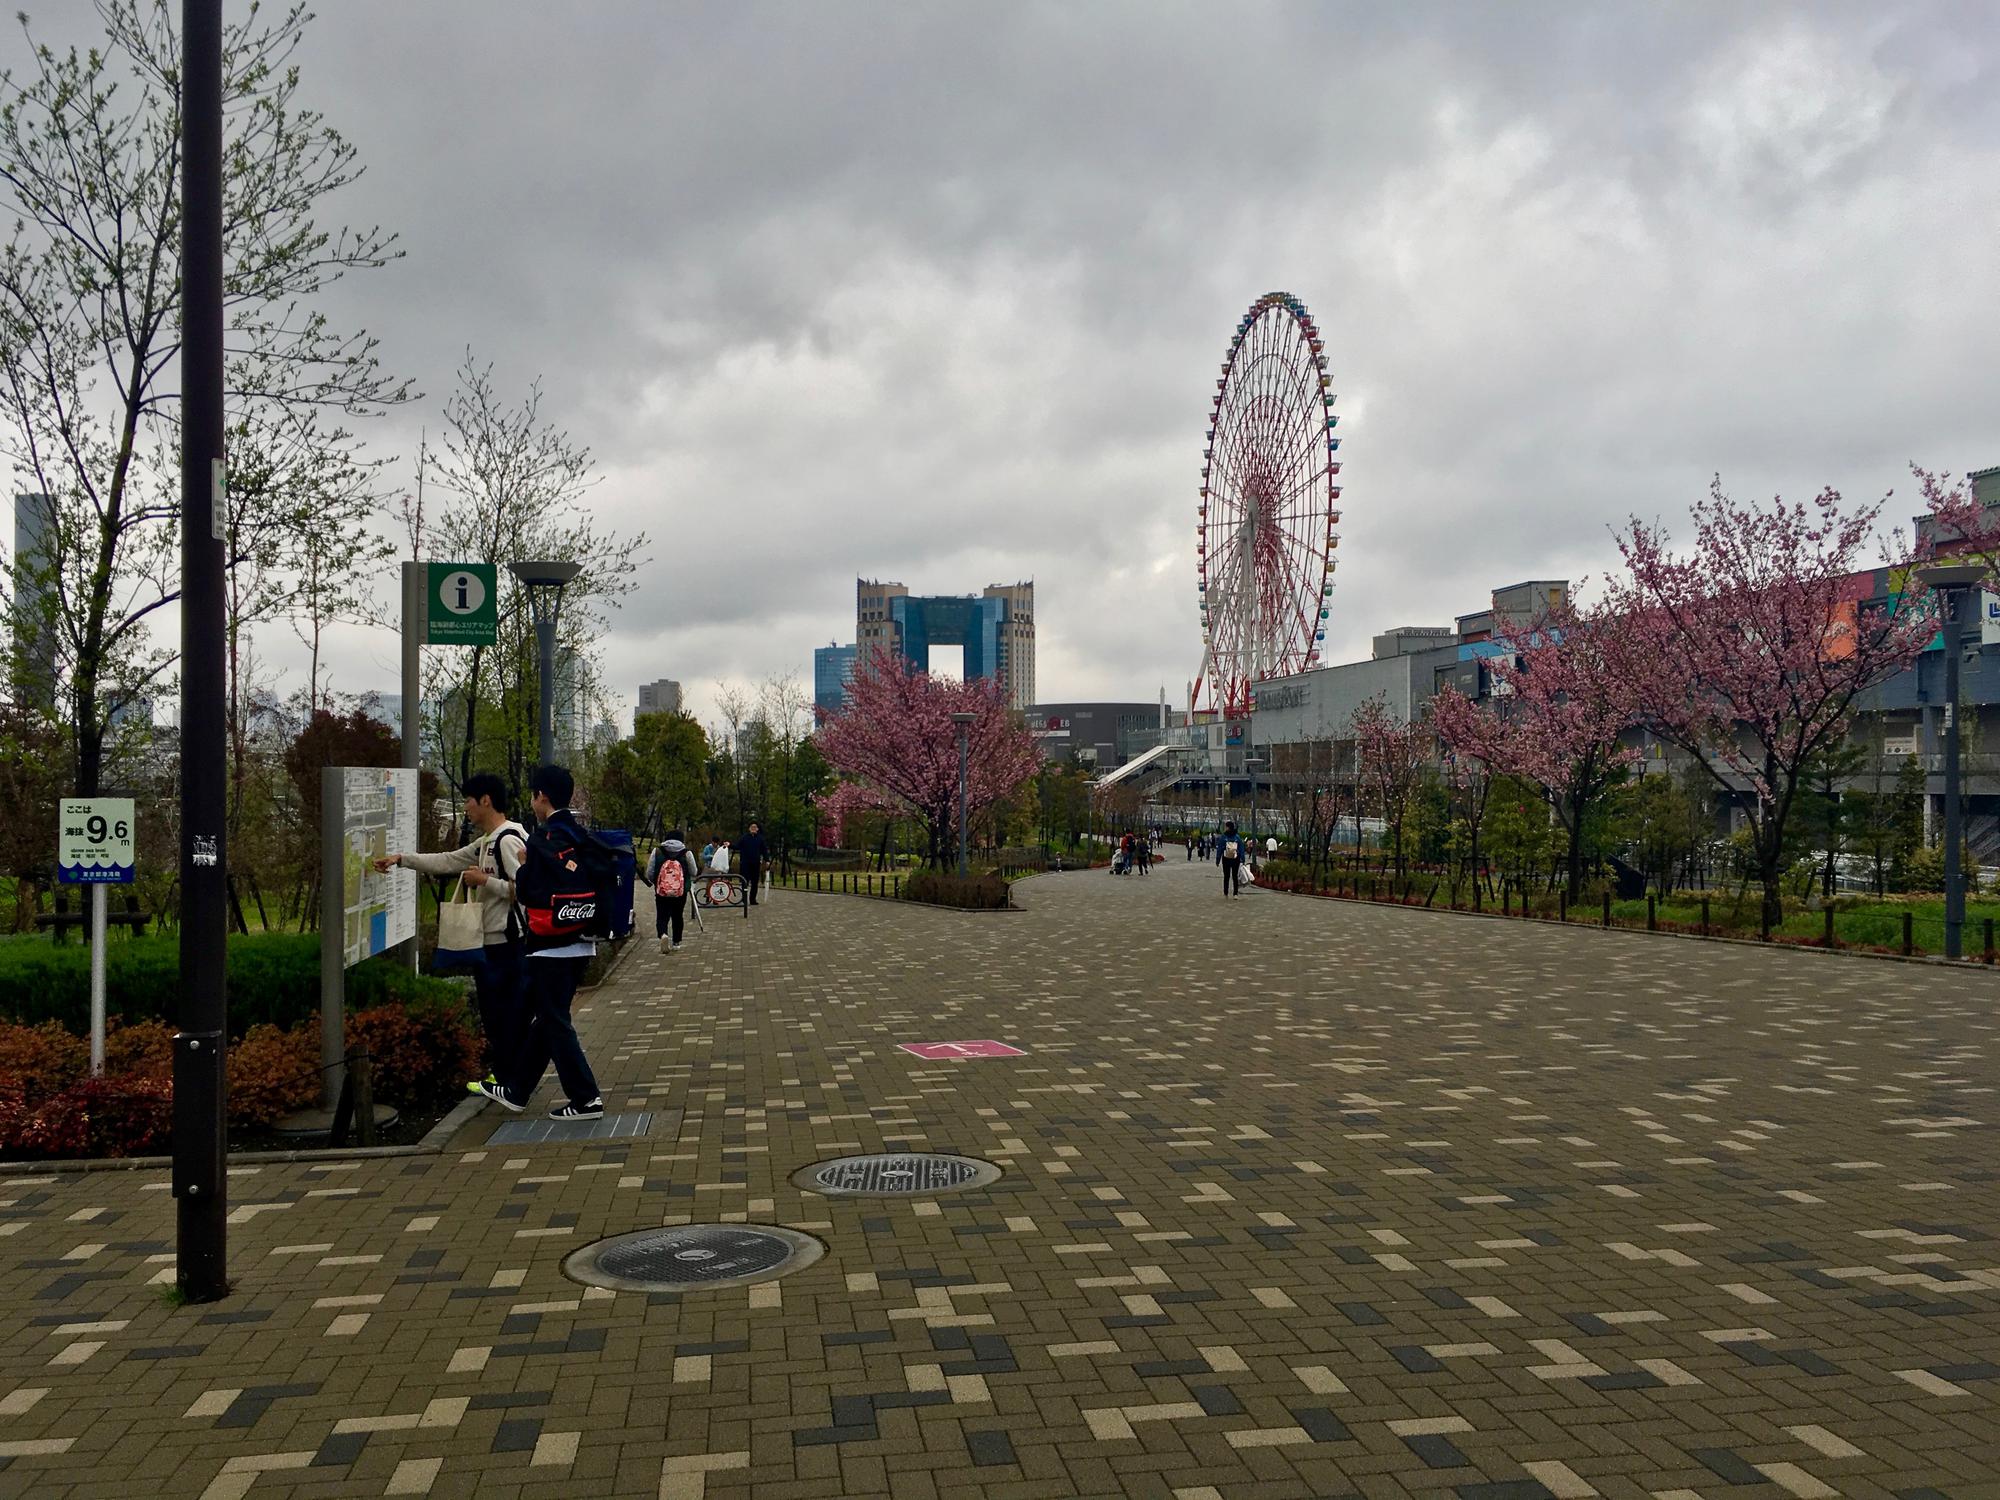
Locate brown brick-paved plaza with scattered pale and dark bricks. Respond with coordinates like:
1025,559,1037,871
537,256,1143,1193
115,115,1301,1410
0,856,2000,1500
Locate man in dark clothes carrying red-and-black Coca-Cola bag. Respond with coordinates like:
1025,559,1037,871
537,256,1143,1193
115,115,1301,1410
472,766,616,1120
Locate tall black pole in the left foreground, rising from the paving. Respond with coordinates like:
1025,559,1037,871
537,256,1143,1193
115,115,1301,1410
172,0,230,1302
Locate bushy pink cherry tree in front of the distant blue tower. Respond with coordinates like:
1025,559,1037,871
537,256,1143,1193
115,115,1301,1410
816,650,1040,864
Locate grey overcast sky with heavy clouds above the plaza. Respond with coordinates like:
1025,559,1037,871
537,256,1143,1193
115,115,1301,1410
27,0,2000,736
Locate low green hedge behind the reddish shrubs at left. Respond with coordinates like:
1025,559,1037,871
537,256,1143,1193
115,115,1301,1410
0,932,462,1036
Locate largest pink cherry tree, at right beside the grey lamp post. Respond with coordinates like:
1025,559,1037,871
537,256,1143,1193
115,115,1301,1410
1606,480,1938,926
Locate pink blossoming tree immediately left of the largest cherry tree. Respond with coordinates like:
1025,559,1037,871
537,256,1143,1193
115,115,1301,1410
1430,604,1638,902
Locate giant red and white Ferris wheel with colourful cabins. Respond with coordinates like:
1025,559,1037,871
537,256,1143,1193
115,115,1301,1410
1188,292,1340,716
